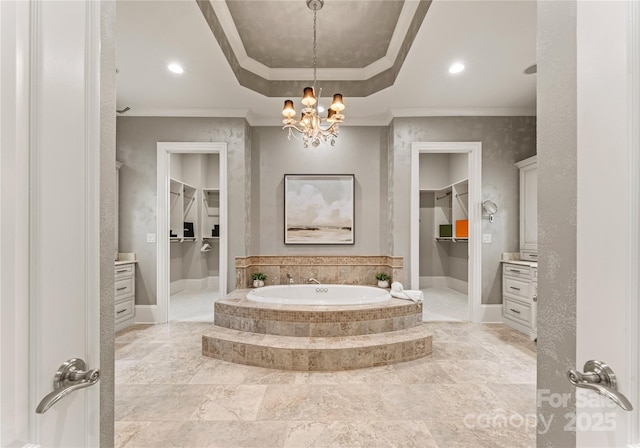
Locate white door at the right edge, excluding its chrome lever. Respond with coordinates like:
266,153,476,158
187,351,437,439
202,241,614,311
566,2,640,447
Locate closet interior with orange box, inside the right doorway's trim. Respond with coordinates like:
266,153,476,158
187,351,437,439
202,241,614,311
419,153,469,320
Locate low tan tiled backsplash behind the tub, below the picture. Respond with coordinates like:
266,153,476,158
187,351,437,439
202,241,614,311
236,255,402,289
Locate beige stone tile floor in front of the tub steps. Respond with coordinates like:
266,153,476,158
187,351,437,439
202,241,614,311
115,322,536,448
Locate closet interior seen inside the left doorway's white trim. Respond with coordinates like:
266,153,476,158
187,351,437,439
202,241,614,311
167,153,221,321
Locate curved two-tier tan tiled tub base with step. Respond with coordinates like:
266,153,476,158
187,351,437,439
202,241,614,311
202,290,432,371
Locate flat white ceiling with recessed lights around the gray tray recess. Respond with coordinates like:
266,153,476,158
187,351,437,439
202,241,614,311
116,0,536,126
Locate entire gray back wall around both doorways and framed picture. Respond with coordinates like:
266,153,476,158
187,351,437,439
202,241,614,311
117,117,535,304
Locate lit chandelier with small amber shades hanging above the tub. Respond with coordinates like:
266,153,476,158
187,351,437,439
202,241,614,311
282,0,344,148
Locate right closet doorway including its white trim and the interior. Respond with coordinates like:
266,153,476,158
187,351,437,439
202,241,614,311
410,142,484,322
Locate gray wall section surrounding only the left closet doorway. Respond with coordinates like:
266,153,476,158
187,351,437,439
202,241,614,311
116,116,251,305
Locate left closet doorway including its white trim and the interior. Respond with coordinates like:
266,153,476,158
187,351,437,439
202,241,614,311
157,142,227,323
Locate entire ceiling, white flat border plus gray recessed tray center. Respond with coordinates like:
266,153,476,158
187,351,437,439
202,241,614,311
116,0,536,126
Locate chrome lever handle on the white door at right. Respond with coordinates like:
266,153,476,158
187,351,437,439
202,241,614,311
567,360,633,411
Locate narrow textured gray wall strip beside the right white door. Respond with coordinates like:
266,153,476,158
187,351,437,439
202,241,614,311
537,2,577,447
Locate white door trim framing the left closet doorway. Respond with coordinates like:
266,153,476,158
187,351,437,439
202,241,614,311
156,142,229,323
